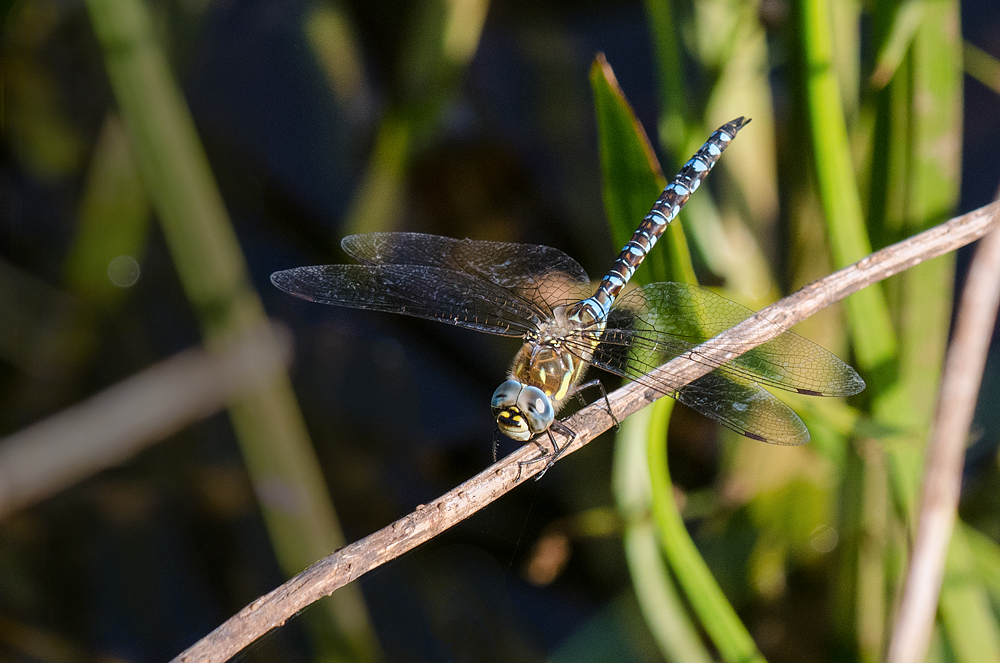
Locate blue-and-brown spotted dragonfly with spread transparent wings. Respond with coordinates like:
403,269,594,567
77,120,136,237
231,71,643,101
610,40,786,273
271,117,865,469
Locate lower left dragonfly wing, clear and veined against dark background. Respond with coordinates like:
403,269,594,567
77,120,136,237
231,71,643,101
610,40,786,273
271,265,538,336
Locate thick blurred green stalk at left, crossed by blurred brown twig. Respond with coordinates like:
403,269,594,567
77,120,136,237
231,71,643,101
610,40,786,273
87,0,377,661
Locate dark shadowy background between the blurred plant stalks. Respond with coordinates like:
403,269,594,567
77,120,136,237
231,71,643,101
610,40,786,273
0,0,1000,662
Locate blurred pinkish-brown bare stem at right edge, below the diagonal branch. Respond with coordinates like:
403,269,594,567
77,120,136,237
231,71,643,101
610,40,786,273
886,215,1000,663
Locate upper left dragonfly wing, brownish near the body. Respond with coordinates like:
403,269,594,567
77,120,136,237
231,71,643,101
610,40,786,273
341,233,591,313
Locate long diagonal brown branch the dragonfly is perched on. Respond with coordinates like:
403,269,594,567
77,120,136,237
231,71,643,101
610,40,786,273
174,198,1000,663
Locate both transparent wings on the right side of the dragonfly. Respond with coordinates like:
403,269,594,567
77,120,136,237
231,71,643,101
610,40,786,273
552,283,864,444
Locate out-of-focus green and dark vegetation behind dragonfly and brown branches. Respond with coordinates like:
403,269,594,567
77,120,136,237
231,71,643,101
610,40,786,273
0,0,1000,662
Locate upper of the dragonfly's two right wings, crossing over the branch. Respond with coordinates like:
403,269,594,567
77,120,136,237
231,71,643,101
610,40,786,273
608,283,865,396
